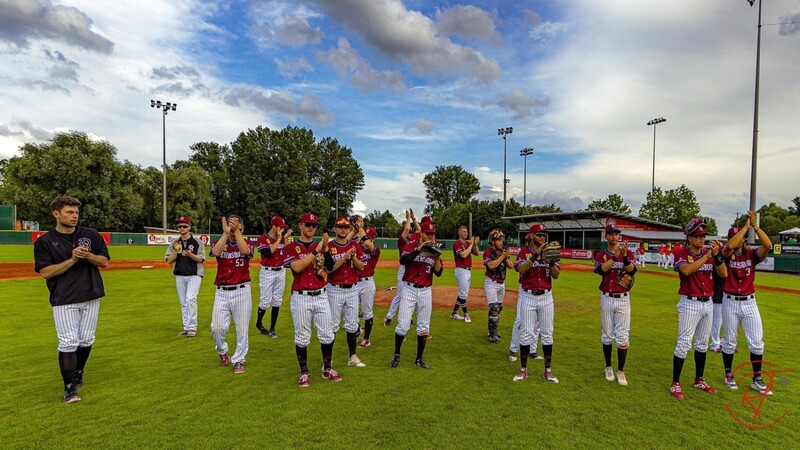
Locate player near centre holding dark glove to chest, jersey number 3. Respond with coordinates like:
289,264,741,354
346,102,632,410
389,222,443,369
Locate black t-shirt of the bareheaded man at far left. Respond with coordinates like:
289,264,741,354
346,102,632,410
33,226,111,306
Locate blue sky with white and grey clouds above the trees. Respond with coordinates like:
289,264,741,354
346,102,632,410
0,0,800,228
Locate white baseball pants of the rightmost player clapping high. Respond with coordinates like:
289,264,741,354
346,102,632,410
722,294,764,355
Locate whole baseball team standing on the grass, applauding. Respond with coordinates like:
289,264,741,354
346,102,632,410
34,195,772,404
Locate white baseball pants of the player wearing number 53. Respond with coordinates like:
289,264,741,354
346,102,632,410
211,282,253,364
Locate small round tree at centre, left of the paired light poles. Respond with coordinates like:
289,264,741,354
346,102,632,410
422,166,481,214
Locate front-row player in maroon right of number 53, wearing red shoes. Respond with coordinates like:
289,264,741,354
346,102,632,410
283,213,342,388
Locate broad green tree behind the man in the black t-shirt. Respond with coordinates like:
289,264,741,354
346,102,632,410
0,131,143,231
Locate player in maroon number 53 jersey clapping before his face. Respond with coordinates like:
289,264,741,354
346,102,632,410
211,214,253,374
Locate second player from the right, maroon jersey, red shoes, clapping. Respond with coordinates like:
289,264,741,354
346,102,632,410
669,217,728,400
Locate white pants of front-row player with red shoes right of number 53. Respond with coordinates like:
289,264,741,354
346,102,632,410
289,288,334,347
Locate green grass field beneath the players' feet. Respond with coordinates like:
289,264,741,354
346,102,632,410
0,255,800,449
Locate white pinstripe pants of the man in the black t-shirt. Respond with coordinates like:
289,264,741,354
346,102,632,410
53,298,100,353
